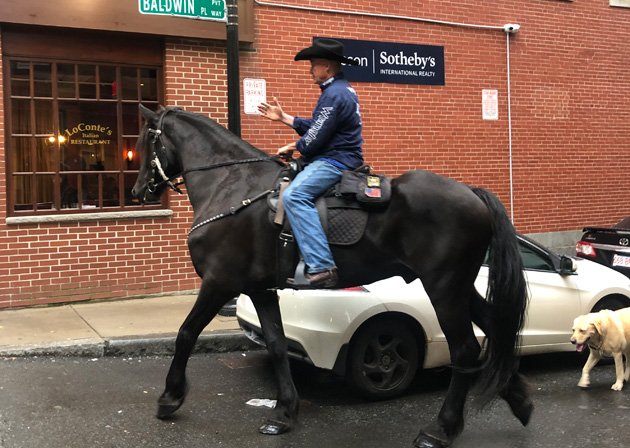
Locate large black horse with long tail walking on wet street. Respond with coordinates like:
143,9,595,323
133,106,533,447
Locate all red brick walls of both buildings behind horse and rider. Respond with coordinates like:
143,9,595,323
0,0,630,307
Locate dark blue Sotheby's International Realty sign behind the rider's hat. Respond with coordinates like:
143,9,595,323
318,37,444,86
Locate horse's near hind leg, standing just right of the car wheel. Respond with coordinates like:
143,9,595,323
414,275,481,448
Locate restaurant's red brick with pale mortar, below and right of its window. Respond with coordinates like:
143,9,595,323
0,37,207,308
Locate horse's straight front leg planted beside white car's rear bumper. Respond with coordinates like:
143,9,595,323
250,291,299,435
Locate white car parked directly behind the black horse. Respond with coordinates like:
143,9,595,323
236,236,630,399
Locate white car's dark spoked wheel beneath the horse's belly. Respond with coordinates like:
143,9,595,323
347,319,421,400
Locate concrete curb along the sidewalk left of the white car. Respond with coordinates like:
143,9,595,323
0,330,260,358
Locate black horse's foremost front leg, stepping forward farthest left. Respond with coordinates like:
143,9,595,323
157,282,232,419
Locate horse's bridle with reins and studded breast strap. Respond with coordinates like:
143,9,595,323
144,109,282,235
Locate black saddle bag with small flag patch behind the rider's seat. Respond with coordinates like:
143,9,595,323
339,171,392,208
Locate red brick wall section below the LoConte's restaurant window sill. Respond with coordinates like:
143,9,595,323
0,219,200,307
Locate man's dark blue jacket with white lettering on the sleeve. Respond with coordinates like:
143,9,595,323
293,73,363,169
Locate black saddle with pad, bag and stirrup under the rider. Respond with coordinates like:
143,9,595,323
267,159,391,285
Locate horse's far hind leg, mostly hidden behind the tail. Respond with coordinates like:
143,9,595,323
471,291,534,426
